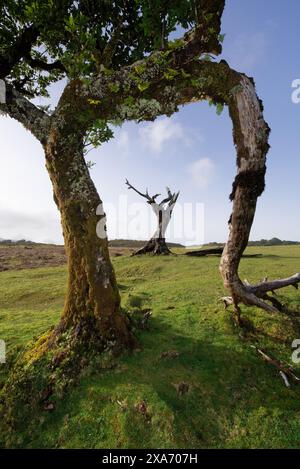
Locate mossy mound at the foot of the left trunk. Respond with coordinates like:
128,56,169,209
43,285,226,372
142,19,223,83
0,320,124,447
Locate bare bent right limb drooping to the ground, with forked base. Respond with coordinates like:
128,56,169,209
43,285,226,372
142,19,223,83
220,75,300,319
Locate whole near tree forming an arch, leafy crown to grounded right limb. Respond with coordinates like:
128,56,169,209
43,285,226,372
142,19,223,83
0,0,300,406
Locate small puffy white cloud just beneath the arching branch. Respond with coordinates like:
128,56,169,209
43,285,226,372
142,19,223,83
139,117,185,153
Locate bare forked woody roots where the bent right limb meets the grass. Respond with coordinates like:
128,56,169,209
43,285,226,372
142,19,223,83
222,273,300,318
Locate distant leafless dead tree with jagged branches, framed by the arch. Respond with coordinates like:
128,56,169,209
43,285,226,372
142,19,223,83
126,179,179,256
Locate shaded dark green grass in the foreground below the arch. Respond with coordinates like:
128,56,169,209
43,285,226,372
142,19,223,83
14,317,300,448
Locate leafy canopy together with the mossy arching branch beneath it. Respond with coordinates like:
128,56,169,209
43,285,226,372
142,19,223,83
0,0,225,151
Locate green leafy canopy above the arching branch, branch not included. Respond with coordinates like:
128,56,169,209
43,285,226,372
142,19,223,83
0,0,224,97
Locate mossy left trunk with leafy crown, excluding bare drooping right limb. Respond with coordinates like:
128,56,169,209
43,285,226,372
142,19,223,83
0,0,223,354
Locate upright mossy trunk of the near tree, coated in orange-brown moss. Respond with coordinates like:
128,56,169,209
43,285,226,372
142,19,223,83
45,128,134,347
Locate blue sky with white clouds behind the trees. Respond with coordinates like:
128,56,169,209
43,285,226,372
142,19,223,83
0,0,300,245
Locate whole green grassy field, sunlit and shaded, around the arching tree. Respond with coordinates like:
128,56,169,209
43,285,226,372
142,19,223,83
0,246,300,448
